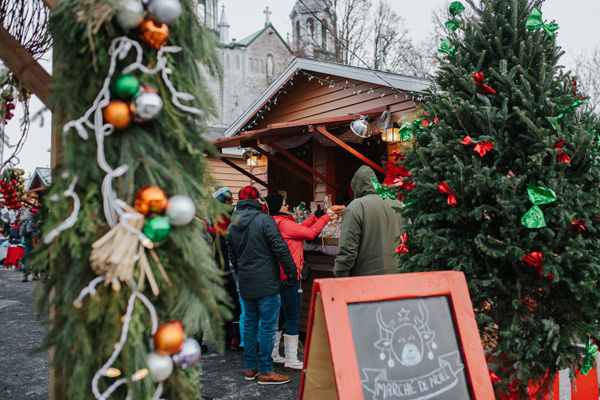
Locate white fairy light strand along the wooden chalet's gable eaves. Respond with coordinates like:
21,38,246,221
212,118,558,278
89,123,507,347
240,69,424,132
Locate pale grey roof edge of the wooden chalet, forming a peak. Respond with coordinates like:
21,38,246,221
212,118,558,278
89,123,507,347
224,57,429,137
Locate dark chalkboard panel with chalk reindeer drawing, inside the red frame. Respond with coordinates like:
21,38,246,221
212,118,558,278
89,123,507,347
348,296,472,400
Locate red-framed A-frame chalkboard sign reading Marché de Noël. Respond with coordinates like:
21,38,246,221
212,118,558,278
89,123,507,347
299,271,494,400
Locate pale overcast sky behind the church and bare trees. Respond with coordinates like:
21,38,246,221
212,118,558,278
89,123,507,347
4,0,600,175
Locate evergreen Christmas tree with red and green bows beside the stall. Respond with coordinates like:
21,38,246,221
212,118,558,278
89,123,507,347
398,0,600,398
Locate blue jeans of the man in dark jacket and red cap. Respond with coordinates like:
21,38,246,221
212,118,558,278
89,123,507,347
242,293,281,374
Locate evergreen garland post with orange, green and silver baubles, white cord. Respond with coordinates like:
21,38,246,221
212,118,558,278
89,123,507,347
36,0,230,399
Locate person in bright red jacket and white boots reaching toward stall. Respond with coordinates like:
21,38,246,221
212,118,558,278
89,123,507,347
265,194,329,370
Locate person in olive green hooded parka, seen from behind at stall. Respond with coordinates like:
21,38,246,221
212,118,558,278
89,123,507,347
333,165,404,277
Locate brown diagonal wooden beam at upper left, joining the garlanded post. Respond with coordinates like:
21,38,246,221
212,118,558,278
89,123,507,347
0,26,52,105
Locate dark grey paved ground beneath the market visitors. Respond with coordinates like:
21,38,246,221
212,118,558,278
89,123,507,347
0,267,300,400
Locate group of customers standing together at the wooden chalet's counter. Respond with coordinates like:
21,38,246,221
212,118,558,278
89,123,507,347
210,166,403,385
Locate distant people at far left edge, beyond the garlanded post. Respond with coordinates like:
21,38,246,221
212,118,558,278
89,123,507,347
0,206,40,282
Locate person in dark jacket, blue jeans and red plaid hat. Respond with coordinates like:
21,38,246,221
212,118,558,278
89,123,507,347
226,186,298,385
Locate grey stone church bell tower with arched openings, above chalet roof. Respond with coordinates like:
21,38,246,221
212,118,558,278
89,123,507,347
290,0,334,59
